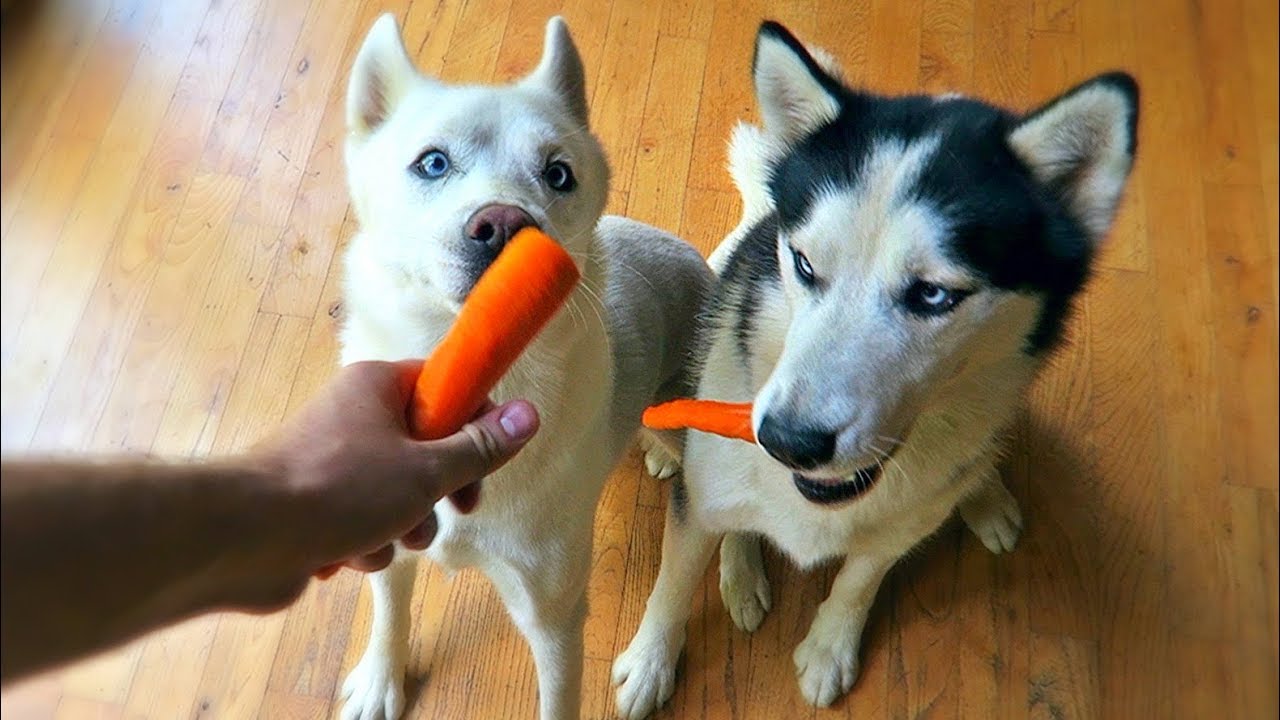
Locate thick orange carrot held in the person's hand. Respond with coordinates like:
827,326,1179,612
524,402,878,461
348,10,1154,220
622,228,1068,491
410,228,579,439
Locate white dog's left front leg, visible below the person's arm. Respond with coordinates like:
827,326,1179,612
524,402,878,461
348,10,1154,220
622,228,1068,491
342,548,417,720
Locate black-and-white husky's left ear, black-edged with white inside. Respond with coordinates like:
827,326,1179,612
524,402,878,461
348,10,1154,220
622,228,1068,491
751,20,840,142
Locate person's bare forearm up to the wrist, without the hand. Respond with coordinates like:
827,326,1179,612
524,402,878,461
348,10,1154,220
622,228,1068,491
0,460,296,680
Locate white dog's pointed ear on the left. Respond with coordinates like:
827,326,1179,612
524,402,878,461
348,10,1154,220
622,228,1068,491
347,13,417,136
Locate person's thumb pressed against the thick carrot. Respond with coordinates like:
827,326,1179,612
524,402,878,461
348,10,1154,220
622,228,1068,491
413,400,539,497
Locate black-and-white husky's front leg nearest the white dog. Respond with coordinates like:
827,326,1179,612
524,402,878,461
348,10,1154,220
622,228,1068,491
613,479,719,720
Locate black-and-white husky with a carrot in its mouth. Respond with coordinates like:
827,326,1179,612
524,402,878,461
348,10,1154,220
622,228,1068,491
613,23,1138,717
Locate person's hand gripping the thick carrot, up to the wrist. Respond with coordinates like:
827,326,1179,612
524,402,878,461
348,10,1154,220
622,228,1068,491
247,361,538,589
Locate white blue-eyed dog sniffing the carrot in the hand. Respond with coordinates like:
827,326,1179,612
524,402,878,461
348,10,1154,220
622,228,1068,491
342,15,714,720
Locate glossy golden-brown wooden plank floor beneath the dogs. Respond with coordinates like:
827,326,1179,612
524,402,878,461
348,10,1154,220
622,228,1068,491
0,0,1277,720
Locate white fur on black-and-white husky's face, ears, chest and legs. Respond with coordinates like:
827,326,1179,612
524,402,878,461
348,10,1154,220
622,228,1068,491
613,23,1128,719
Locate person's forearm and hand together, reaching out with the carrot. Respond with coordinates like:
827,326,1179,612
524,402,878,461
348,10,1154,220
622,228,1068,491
0,361,538,680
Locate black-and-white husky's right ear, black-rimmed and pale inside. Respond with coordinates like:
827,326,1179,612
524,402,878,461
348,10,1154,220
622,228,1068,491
1009,73,1138,242
